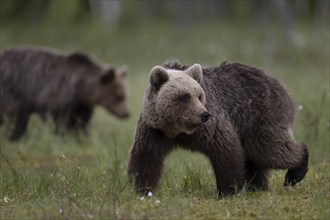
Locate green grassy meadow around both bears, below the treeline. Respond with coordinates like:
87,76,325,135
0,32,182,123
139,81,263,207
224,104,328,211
0,19,330,219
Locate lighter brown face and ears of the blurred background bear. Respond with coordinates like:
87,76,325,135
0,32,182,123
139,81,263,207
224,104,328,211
83,68,130,118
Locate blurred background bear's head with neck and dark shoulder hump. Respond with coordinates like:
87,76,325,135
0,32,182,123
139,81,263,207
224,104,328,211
69,53,129,118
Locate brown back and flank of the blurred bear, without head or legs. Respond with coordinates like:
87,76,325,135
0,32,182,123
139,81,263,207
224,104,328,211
0,46,89,110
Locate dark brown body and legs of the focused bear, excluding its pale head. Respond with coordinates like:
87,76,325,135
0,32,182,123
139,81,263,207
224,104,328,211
128,62,308,196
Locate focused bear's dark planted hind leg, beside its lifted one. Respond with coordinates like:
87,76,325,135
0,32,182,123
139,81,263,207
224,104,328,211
245,160,269,191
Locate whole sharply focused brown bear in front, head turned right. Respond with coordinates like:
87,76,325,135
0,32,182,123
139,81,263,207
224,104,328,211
128,61,308,196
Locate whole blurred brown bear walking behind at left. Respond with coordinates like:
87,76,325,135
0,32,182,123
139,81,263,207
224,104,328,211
0,46,129,140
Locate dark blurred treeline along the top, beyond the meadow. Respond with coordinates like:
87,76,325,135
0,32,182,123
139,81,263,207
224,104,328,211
0,0,330,28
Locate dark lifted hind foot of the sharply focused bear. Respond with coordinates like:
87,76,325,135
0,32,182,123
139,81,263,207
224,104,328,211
284,143,309,186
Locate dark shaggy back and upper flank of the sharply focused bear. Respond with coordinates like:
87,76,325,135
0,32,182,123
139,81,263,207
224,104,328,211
202,63,295,133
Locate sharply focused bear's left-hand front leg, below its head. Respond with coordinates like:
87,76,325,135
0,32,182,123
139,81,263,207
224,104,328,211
128,118,173,194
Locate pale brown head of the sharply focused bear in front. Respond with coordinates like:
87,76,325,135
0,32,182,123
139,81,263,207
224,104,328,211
142,64,211,138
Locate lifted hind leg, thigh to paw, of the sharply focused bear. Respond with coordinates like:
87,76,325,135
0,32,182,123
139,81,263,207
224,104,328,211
245,126,308,186
